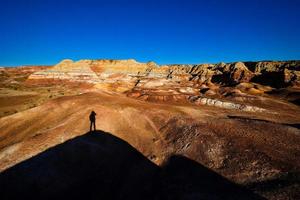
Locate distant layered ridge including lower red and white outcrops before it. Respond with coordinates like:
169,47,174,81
26,59,300,112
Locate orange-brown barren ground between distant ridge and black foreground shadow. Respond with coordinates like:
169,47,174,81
0,64,300,199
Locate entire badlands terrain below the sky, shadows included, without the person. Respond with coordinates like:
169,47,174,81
0,59,300,200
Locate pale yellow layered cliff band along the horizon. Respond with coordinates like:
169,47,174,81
28,59,300,87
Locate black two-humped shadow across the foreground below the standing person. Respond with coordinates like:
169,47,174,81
0,131,261,200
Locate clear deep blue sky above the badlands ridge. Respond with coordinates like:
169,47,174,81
0,0,300,66
